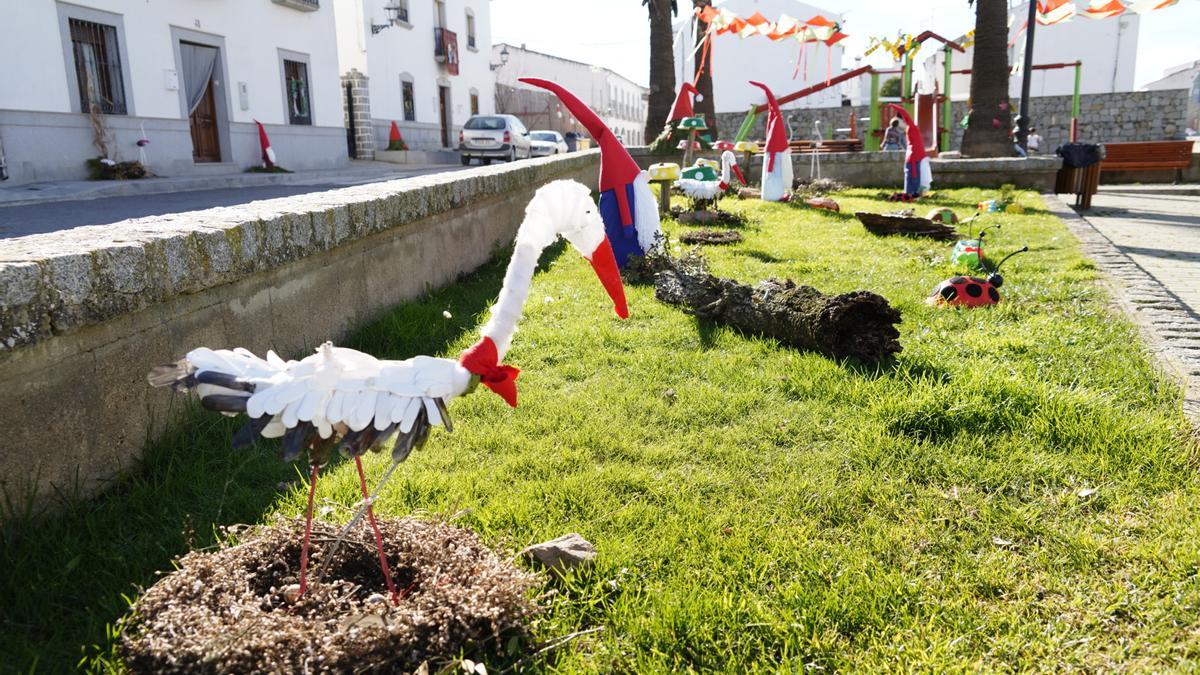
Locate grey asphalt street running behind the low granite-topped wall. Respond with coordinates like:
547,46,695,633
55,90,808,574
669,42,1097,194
0,165,462,239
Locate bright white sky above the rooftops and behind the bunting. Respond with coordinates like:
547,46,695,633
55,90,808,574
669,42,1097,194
491,0,1200,88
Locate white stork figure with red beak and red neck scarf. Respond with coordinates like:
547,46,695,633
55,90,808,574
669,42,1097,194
149,180,629,602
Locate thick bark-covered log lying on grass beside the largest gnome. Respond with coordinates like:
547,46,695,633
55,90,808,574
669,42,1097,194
654,256,901,363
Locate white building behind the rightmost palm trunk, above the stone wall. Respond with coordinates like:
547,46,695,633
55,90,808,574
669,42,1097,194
923,1,1140,101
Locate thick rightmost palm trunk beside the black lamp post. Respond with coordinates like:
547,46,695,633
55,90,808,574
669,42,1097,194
962,0,1013,157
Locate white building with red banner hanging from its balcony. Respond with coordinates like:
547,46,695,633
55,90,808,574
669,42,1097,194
332,0,496,150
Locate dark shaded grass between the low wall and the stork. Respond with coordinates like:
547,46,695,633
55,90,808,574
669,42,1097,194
0,240,530,673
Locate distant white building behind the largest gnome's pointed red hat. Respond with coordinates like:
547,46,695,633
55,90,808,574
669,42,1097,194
492,43,649,145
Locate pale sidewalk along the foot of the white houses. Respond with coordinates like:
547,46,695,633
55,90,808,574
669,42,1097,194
0,160,460,208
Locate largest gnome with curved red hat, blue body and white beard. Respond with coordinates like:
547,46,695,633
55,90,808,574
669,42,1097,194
521,77,662,268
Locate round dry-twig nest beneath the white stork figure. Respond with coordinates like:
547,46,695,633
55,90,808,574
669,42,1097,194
121,518,538,673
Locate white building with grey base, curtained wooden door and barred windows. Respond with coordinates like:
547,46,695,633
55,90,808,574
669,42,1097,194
0,0,348,183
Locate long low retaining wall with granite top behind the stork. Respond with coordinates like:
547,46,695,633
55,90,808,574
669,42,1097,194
0,150,599,500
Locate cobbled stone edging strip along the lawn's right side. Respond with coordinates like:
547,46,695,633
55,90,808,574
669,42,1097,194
1042,195,1200,422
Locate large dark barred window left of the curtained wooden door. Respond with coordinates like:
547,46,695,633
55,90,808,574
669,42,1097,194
67,19,126,115
